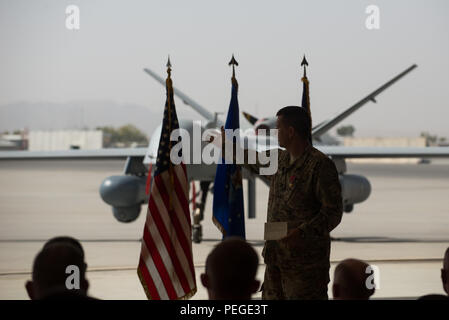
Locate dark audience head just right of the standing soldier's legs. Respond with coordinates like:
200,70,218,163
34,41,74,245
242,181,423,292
332,259,375,300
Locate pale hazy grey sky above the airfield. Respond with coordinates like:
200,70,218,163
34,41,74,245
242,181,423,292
0,0,449,137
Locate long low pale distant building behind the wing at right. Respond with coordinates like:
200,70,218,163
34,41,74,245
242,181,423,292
343,137,427,163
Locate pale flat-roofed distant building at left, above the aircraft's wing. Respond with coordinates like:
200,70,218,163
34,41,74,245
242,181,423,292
28,130,103,151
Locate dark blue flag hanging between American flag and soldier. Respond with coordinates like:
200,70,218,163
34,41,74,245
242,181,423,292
212,77,245,239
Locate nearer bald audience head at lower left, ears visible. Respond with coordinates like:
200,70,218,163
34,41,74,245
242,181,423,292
26,243,88,300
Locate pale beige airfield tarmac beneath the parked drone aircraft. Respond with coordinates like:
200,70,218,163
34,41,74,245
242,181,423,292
0,160,449,299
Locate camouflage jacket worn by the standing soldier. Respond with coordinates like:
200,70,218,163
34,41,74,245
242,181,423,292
245,145,343,265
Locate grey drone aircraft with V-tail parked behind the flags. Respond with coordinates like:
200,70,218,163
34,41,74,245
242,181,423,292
0,65,449,242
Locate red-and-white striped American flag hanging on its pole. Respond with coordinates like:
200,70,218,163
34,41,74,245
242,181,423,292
137,60,196,300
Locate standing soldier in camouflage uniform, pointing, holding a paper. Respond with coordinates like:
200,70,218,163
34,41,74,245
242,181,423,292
231,106,343,300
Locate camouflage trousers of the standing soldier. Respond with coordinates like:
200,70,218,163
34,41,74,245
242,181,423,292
262,261,330,300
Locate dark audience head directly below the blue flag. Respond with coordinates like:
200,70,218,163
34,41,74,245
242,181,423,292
201,237,260,300
